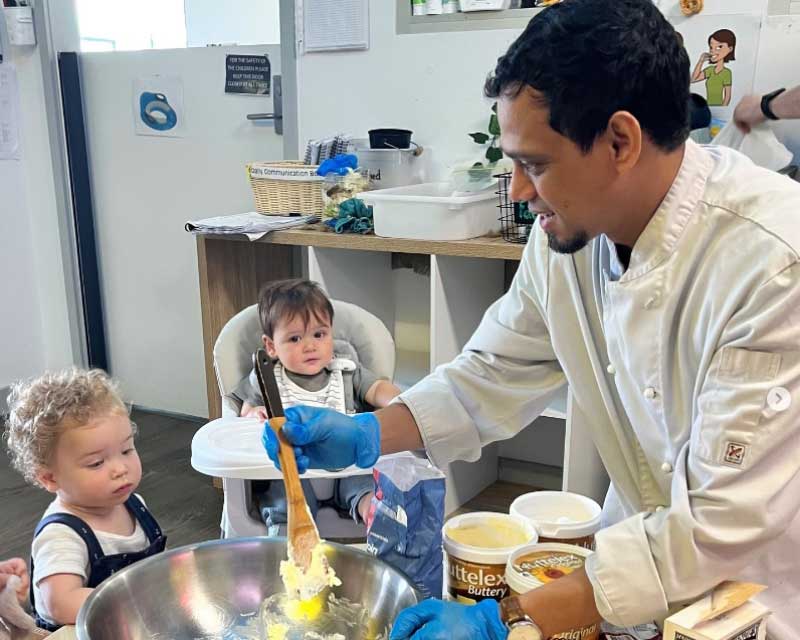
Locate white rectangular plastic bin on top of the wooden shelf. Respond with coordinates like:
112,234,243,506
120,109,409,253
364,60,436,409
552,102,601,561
357,182,500,240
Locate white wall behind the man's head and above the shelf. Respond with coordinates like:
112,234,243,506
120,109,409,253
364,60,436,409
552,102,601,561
298,0,800,171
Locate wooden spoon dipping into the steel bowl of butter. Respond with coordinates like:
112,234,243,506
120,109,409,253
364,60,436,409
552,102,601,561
269,416,319,571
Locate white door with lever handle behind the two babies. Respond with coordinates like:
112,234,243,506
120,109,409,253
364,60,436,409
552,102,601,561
58,2,296,416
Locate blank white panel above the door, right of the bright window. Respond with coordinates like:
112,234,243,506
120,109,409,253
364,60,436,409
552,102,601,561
184,0,281,47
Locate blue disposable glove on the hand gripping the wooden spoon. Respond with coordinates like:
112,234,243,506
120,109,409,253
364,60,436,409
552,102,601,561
261,406,381,473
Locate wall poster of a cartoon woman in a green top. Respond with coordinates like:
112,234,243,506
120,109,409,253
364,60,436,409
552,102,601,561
675,13,761,122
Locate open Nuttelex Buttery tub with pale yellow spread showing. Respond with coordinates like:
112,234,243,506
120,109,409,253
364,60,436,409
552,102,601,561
443,512,537,604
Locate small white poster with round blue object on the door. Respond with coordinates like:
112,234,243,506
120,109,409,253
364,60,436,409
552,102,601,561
133,75,184,138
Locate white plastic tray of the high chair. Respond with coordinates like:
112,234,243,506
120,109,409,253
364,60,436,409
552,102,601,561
192,418,411,480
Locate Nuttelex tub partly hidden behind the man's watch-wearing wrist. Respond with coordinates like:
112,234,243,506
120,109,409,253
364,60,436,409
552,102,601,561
506,542,600,640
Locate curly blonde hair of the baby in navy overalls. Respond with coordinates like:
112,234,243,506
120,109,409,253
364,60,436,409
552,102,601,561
6,368,130,486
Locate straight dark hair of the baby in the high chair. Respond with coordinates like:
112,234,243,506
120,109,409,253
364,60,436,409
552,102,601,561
258,278,333,338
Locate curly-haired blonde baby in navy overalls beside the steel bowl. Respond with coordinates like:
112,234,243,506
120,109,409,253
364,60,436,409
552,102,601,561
7,369,166,631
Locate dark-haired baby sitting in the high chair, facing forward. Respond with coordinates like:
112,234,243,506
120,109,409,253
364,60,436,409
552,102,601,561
231,279,400,534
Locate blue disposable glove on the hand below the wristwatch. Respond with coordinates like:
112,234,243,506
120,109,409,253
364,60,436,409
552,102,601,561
389,599,508,640
